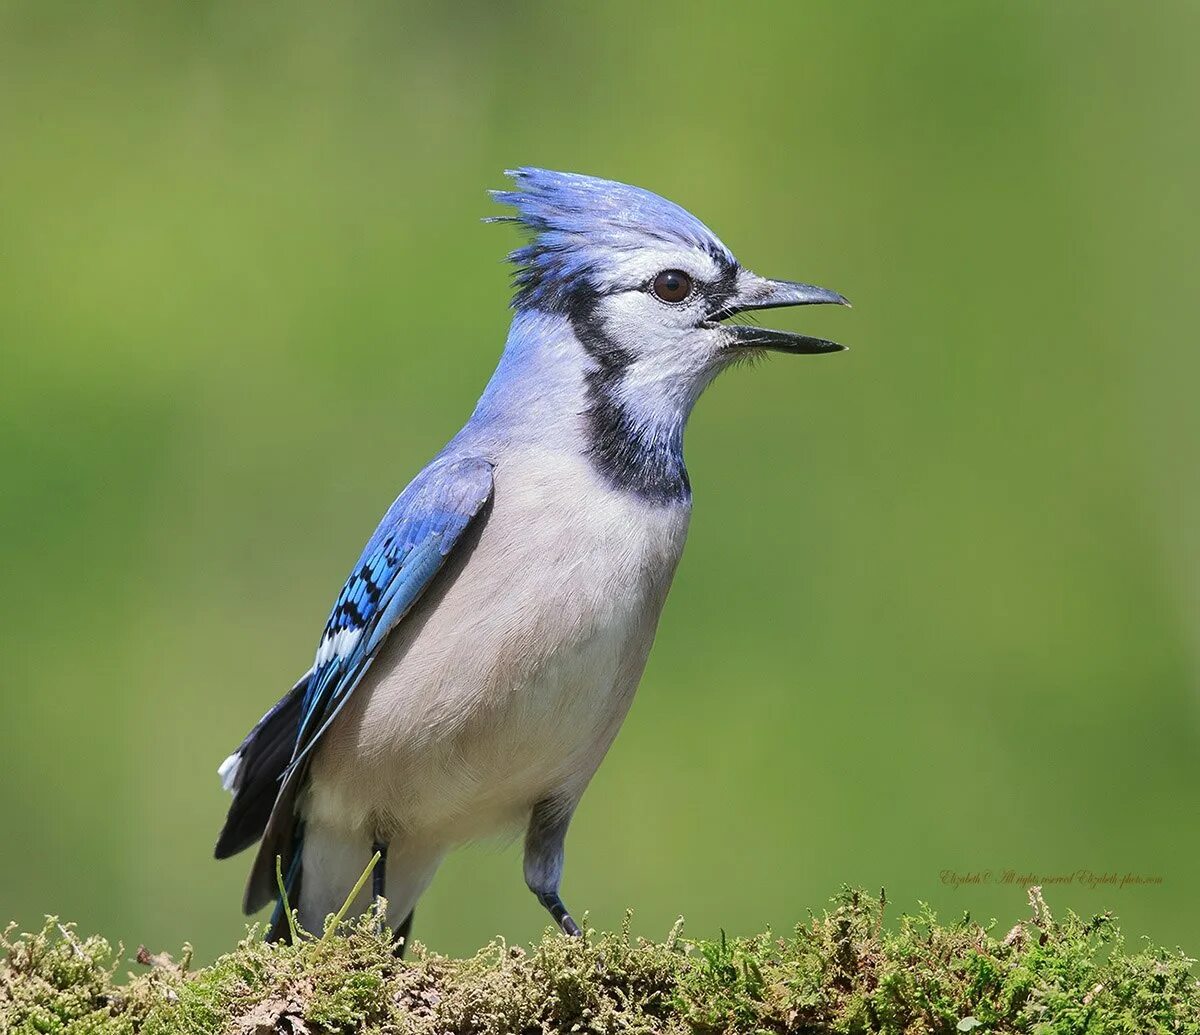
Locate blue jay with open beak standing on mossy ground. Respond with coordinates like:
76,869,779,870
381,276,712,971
216,168,848,939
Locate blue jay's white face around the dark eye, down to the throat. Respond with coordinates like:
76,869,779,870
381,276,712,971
585,245,731,417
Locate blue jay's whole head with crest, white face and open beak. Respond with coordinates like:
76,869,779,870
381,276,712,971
493,168,848,408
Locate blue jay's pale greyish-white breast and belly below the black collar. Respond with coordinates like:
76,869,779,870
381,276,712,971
304,450,689,836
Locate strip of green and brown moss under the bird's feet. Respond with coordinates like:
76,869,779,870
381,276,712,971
0,889,1200,1035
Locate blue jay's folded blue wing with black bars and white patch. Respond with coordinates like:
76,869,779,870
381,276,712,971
284,457,492,776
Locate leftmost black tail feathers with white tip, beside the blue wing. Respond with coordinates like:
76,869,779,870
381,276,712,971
215,672,312,858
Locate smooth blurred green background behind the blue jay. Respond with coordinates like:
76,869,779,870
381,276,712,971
0,2,1200,958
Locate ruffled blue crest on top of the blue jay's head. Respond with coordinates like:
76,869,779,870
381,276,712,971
487,168,736,310
